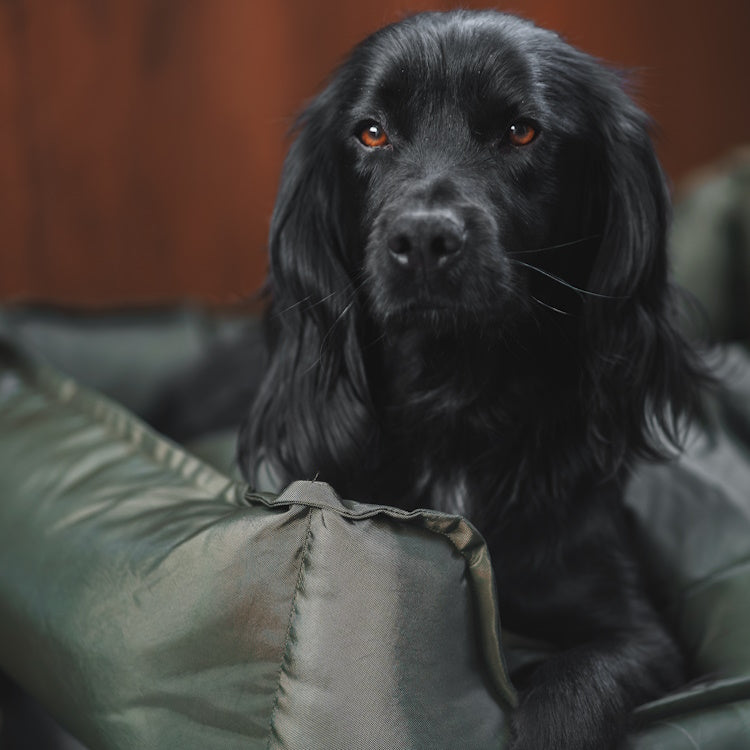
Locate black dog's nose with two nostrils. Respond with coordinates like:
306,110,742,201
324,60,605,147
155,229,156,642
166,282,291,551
387,210,466,271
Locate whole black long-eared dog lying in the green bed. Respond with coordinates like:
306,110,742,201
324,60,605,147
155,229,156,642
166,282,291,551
240,12,701,750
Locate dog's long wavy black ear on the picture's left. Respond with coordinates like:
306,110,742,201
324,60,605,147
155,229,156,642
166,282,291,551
238,85,371,490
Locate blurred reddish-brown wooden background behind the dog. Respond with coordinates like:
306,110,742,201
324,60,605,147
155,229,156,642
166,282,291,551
0,0,750,305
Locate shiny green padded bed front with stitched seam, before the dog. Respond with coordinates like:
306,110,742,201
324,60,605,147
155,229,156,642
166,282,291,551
0,354,513,750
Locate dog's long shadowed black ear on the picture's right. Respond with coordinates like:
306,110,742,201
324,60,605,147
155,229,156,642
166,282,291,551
584,71,703,466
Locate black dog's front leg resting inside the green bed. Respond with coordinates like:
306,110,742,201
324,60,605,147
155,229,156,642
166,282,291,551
491,496,683,750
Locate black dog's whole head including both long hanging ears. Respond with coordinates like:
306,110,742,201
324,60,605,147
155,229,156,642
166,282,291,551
244,11,708,488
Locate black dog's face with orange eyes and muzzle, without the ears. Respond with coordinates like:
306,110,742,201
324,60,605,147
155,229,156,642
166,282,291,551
326,14,601,325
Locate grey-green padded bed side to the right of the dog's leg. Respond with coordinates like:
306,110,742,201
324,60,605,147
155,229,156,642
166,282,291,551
629,348,750,680
